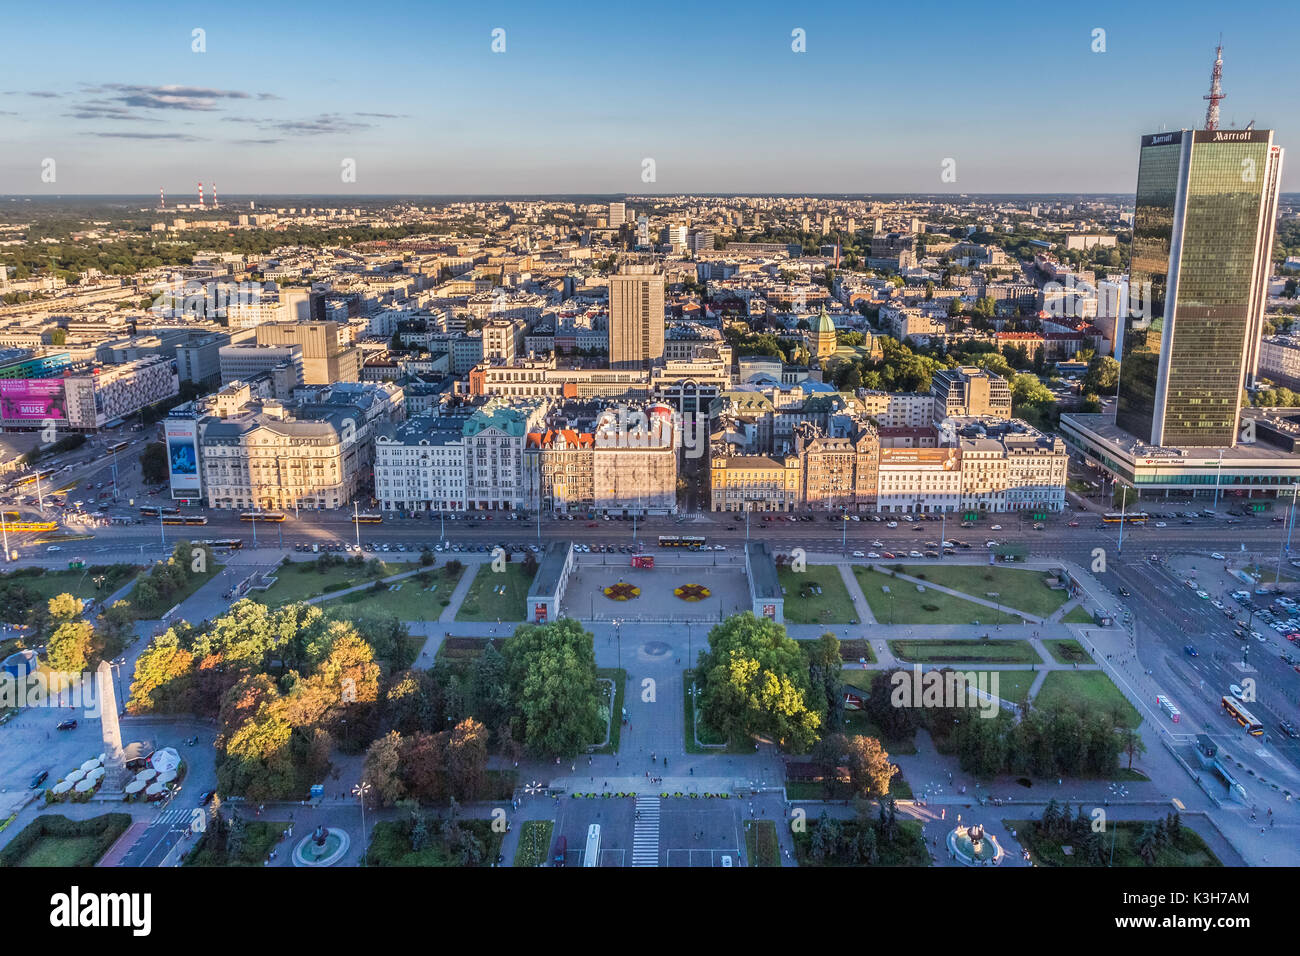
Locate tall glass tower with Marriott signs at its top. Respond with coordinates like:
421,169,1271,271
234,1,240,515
1115,129,1283,447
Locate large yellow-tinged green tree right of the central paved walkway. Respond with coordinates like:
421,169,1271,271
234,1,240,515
697,611,823,753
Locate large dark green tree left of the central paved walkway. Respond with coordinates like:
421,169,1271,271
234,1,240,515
504,618,602,757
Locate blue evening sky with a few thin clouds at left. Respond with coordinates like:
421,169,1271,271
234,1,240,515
0,0,1300,202
